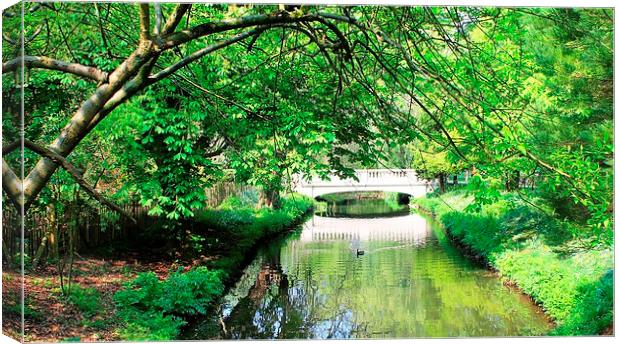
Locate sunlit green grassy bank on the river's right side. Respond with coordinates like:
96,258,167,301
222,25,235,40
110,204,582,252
415,190,613,335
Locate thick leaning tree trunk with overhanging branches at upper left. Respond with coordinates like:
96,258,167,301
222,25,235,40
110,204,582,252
3,5,358,210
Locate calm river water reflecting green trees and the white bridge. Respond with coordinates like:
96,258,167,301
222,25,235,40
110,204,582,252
185,200,552,339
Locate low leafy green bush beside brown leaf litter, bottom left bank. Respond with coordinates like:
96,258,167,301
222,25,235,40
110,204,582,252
114,267,224,340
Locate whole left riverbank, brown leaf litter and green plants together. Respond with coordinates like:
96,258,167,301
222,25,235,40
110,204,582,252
3,195,314,341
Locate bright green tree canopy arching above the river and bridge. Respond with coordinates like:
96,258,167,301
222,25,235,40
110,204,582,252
2,2,613,238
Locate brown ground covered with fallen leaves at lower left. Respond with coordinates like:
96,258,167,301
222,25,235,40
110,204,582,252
2,253,208,342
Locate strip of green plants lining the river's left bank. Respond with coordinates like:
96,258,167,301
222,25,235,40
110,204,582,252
114,195,313,341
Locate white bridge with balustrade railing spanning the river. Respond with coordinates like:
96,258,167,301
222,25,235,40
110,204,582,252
293,169,438,198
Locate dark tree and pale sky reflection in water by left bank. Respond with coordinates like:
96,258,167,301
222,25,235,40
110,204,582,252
226,249,366,339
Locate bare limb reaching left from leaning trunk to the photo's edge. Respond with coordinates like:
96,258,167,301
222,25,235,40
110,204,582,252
2,56,108,82
